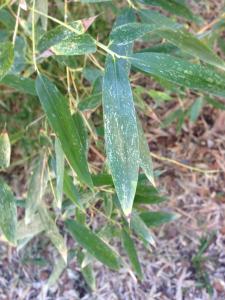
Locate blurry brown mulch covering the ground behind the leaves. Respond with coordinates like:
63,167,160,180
0,1,225,300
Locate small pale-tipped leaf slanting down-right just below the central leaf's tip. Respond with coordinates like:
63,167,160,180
130,212,155,246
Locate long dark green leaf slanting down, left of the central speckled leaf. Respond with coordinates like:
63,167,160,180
36,75,92,188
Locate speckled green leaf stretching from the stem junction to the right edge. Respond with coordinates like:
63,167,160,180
131,53,225,96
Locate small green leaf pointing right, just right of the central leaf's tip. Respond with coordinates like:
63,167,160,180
140,211,179,227
